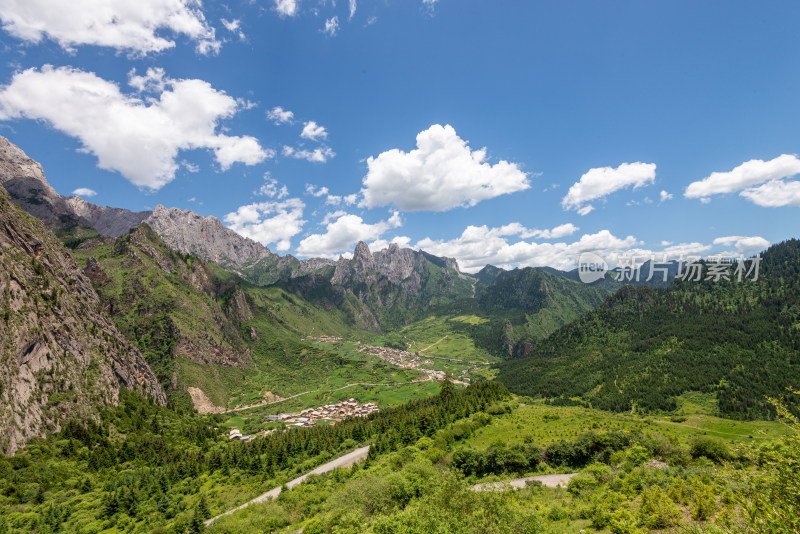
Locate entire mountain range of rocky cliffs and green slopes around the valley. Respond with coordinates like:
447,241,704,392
0,133,800,452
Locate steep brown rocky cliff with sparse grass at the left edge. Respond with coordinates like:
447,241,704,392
0,187,166,454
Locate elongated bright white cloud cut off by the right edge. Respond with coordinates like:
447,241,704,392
684,154,800,205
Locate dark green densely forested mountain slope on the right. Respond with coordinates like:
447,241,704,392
498,240,800,418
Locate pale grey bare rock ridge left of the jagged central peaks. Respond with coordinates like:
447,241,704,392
146,204,274,270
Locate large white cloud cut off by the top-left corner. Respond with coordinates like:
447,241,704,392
0,0,221,55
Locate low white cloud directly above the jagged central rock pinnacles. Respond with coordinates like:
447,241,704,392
297,212,401,258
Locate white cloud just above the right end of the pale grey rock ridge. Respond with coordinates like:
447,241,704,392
225,198,306,251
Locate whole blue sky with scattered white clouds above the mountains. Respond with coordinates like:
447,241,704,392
0,0,800,271
